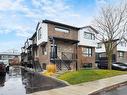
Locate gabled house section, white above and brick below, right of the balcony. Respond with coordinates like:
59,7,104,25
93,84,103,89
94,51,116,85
78,26,98,68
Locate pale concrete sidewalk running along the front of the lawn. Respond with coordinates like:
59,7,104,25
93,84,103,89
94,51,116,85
31,74,127,95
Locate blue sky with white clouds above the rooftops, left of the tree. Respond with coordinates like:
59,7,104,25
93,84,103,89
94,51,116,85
0,0,119,52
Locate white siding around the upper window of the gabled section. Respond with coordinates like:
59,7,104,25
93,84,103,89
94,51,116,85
78,28,97,47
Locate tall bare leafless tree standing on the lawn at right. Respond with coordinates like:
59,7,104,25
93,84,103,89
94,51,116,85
93,3,127,69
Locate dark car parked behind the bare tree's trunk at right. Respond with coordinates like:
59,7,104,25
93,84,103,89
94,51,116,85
98,62,127,70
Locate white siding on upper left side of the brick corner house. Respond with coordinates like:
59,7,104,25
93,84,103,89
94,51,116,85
37,23,48,45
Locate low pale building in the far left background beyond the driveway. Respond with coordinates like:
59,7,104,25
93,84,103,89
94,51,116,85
0,52,21,65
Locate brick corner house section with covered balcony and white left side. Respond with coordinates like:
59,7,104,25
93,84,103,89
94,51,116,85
37,20,79,69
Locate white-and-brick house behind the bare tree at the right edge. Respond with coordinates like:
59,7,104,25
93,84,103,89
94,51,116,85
96,41,127,63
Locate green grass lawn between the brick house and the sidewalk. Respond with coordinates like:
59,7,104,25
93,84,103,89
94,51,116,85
58,70,127,84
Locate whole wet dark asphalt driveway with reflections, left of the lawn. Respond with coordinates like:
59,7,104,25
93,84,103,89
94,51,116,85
0,67,67,95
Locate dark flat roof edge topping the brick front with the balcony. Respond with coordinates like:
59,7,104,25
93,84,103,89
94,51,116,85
42,20,80,30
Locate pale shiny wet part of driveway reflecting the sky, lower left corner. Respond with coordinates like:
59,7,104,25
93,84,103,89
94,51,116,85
0,69,26,95
